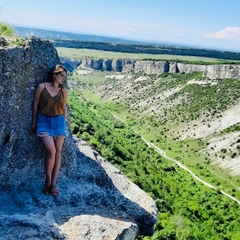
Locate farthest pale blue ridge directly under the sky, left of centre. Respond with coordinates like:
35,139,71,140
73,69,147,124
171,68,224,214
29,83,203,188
14,26,142,44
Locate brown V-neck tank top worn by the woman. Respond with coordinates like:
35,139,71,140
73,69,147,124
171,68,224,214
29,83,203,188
38,86,63,116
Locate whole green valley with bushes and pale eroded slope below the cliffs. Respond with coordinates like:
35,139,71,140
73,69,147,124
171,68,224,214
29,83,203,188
60,47,240,240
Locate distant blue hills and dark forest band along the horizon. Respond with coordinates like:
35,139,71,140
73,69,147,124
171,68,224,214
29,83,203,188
14,26,240,61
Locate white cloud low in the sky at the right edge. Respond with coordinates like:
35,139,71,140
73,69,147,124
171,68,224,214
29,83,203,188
206,26,240,41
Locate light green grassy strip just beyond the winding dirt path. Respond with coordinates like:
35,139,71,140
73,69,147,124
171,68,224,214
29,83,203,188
82,72,240,199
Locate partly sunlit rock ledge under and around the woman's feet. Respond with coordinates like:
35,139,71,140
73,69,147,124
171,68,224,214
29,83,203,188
0,136,157,239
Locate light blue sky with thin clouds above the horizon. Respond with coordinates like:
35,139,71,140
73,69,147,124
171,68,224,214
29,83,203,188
0,0,240,52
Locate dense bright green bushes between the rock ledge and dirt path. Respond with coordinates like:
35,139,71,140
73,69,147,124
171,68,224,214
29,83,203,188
66,85,240,240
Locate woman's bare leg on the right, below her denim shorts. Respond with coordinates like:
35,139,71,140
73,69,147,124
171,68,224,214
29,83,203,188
51,136,64,187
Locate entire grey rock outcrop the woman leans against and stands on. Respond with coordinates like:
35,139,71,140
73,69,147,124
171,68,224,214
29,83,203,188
0,38,157,240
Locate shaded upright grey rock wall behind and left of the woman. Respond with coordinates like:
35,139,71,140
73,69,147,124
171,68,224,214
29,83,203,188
0,39,64,186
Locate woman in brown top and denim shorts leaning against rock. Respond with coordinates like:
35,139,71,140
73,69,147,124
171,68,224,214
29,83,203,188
32,64,68,196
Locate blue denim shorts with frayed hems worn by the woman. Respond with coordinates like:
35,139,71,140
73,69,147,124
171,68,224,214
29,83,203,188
37,113,67,137
